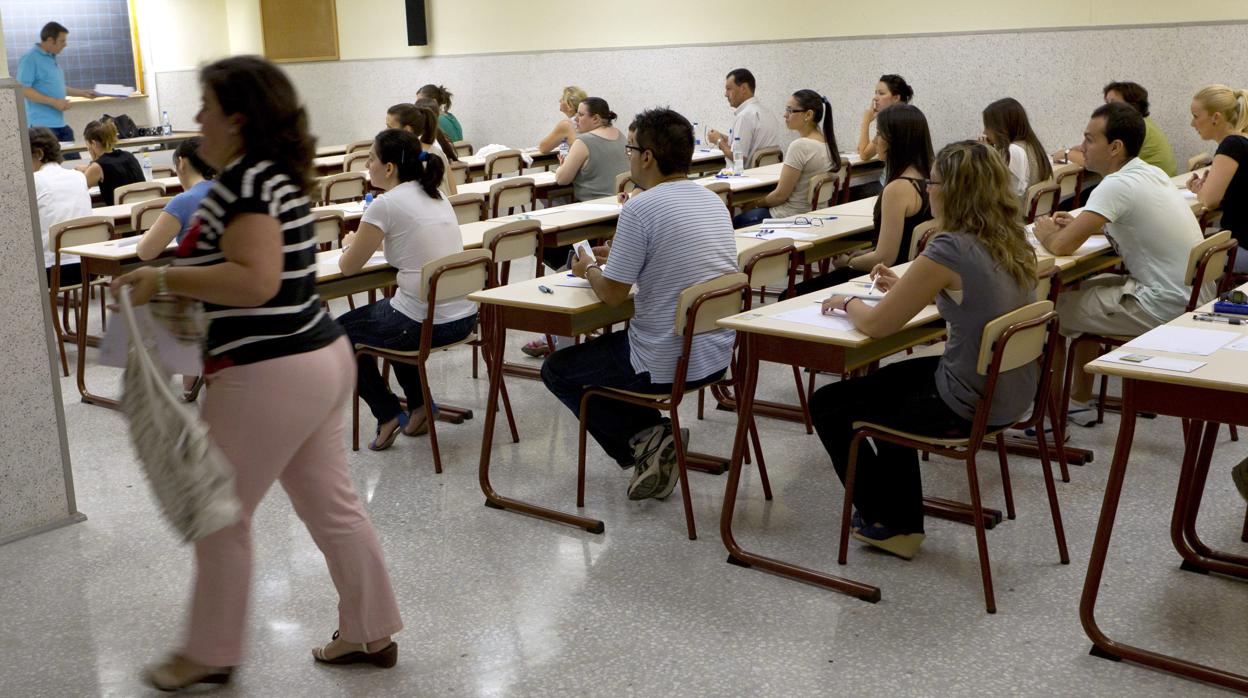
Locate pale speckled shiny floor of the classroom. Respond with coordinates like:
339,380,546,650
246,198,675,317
0,295,1248,697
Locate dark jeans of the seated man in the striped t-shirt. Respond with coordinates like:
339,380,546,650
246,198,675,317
542,332,728,468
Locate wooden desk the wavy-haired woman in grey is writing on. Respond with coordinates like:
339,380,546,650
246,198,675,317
719,273,943,603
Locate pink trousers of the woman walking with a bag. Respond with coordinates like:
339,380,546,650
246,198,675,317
182,338,403,667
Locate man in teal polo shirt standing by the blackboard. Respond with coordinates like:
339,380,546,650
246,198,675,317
17,21,96,148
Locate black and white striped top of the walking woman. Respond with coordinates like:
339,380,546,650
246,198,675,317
176,156,342,373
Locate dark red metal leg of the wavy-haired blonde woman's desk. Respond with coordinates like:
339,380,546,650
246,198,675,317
719,335,880,603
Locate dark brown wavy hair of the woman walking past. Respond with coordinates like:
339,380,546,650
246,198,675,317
200,56,316,192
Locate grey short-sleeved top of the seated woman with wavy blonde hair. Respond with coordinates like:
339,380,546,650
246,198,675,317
922,232,1040,426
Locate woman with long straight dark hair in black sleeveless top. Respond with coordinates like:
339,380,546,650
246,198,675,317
795,104,932,296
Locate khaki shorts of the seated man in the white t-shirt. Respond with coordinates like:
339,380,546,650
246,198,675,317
1057,273,1163,337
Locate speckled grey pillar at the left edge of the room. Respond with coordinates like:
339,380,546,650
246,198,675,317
0,80,81,543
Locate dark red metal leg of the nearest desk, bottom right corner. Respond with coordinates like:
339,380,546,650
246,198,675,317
1080,380,1248,692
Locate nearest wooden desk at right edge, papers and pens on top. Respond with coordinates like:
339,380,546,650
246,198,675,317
1080,295,1248,692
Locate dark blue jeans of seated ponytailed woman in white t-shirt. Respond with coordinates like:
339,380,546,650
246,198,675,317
338,298,477,423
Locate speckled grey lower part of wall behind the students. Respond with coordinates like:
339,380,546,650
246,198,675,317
156,22,1248,162
